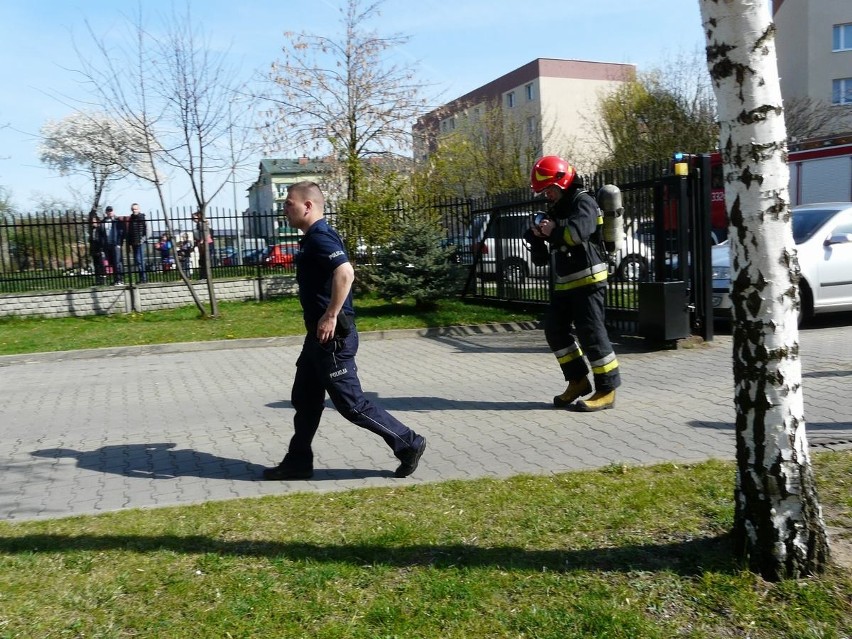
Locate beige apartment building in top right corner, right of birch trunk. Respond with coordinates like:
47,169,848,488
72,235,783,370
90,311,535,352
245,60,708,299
772,0,852,109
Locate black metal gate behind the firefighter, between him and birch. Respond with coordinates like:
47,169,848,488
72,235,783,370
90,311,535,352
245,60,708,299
459,155,713,340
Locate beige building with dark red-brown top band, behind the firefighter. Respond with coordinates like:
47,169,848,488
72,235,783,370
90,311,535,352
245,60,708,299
413,59,632,170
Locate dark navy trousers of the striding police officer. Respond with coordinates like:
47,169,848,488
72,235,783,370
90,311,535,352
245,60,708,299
287,327,417,465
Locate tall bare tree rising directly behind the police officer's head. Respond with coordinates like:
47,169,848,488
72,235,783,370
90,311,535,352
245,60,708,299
264,0,425,201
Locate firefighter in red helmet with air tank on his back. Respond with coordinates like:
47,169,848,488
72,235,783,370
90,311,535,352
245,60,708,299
530,155,621,412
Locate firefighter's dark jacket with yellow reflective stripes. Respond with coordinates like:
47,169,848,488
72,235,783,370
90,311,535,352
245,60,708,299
547,187,608,295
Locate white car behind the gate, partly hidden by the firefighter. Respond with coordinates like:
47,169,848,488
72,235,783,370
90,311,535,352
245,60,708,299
470,211,653,283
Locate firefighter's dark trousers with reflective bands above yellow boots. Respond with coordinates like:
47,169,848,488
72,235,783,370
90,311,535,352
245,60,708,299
544,285,621,392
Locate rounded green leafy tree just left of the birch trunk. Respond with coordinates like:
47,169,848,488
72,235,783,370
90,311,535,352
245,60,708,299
590,52,719,169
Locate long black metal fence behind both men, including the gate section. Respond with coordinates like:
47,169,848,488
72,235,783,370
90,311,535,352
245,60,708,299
0,158,712,338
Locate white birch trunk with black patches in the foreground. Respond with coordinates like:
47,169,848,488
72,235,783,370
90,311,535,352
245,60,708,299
699,0,829,581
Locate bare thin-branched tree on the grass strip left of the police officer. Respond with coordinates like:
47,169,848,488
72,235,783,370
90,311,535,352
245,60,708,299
75,6,254,317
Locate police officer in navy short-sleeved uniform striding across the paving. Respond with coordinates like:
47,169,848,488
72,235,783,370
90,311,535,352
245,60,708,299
263,182,426,480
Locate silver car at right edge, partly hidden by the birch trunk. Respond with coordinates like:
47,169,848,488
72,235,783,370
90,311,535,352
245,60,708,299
713,202,852,324
